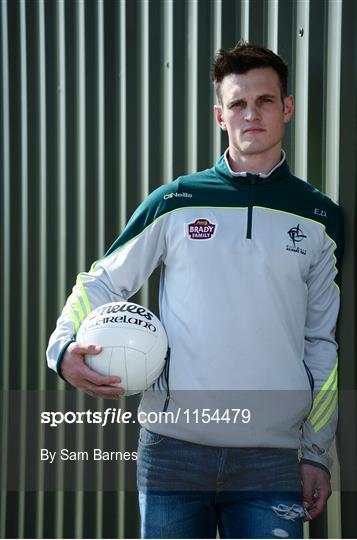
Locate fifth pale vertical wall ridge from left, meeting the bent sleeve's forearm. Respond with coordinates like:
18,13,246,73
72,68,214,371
74,0,87,538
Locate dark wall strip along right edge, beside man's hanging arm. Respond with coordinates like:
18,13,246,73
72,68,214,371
337,0,357,538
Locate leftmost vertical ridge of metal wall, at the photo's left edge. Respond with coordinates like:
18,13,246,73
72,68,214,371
0,0,11,538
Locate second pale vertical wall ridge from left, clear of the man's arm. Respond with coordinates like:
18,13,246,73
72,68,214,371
18,0,29,538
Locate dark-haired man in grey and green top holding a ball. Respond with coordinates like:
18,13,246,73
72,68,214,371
48,43,341,538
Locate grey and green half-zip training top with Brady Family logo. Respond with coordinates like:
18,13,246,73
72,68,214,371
47,155,341,468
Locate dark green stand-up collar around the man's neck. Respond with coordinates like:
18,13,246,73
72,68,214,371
215,149,290,187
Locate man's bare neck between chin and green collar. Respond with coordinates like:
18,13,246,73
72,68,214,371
227,146,281,174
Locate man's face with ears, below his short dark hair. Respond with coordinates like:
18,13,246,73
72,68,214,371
215,68,294,157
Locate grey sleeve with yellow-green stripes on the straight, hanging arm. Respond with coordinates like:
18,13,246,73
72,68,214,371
301,207,342,469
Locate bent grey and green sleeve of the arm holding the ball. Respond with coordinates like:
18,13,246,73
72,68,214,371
47,188,165,374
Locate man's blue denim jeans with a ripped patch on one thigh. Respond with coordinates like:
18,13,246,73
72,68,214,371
137,428,304,538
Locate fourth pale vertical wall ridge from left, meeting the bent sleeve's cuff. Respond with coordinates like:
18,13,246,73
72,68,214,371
54,0,67,538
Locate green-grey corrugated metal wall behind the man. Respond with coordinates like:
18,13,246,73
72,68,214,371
0,0,357,538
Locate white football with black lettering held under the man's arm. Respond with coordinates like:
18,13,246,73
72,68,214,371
76,302,168,395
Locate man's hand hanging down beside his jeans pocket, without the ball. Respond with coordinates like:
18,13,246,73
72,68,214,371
301,463,332,521
